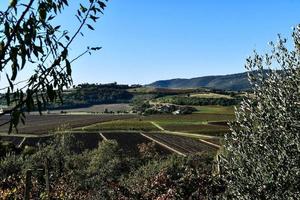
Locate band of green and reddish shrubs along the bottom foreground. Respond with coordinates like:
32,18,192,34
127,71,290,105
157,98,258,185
0,134,216,199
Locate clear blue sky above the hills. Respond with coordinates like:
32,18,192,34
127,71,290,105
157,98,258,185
1,0,300,84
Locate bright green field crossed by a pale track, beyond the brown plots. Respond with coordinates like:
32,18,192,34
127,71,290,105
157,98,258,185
82,106,234,136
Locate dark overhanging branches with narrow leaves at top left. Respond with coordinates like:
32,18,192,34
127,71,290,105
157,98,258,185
0,0,107,131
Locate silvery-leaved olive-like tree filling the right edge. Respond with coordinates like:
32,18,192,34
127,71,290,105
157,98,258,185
220,26,300,199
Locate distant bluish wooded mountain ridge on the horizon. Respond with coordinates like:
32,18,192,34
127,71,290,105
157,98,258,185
148,72,250,91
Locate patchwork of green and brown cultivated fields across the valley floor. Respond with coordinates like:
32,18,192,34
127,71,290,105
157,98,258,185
0,104,234,155
